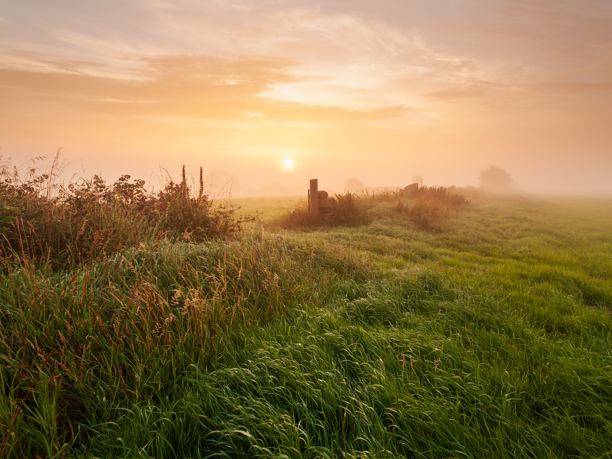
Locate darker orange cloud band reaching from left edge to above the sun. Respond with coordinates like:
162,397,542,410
0,56,412,123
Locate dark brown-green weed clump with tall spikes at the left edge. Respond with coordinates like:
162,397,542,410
0,156,253,266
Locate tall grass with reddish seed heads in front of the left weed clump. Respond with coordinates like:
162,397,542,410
0,235,370,457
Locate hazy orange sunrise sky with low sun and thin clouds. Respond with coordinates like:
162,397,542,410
0,0,612,196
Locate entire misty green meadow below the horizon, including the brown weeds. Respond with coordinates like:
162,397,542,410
0,161,612,458
